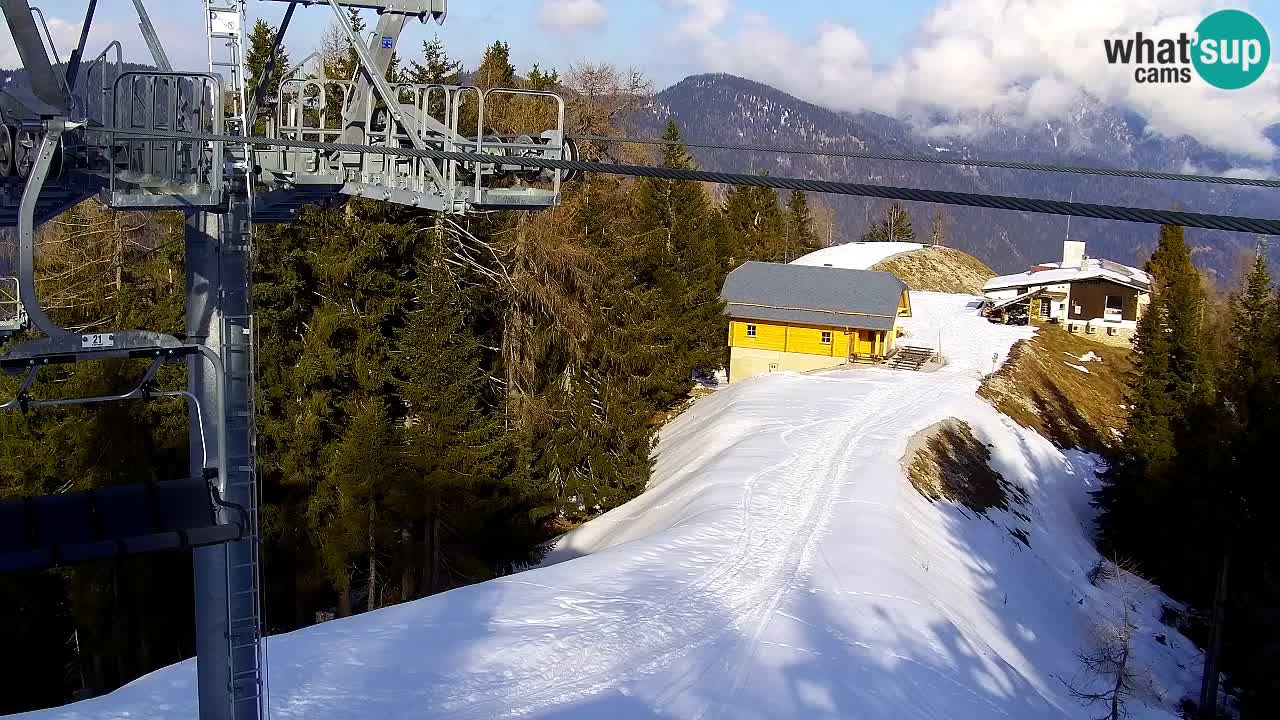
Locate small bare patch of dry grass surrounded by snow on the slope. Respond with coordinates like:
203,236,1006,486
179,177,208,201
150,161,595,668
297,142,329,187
902,418,1027,512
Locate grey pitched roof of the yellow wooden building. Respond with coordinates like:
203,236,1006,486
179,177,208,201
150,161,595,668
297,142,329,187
721,263,906,331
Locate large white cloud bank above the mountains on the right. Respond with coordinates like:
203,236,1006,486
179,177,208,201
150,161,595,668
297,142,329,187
667,0,1280,160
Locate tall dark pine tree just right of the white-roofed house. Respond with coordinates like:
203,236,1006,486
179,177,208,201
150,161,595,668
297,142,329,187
1097,225,1225,600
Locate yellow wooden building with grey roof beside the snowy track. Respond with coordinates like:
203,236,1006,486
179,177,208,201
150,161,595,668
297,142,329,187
721,257,911,383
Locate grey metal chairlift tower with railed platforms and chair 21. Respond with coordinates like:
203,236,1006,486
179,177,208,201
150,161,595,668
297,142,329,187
0,0,576,720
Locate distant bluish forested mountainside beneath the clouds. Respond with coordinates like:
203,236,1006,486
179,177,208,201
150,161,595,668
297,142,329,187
631,74,1280,274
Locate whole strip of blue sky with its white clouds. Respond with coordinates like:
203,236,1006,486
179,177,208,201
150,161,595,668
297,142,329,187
0,0,1280,160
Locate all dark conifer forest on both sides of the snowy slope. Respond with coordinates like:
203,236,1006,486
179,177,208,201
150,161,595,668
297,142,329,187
0,12,1280,719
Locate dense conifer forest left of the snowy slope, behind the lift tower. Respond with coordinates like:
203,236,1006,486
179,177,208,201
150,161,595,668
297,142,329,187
0,23,818,714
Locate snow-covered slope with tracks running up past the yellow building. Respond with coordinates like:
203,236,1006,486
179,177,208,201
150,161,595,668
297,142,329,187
17,293,1198,720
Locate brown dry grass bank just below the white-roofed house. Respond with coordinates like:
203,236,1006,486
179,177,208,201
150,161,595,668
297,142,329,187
978,320,1130,455
